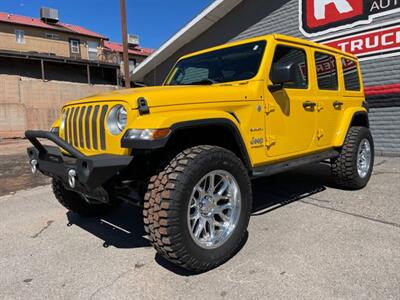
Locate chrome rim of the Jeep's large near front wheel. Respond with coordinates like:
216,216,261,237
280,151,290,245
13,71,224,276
188,170,241,249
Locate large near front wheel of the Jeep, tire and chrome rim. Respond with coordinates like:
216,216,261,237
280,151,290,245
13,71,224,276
143,146,252,272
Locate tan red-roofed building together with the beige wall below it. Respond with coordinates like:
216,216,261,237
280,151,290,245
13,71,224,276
0,9,152,140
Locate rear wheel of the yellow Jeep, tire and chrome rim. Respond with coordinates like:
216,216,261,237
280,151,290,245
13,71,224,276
331,127,374,190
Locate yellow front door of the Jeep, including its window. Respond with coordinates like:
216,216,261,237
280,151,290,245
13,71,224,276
265,43,316,159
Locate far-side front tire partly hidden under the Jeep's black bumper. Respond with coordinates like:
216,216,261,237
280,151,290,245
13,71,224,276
52,179,115,217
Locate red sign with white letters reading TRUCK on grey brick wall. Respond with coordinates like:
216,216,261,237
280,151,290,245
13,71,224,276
324,25,400,57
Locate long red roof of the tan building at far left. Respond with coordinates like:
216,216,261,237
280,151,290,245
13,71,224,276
0,12,108,40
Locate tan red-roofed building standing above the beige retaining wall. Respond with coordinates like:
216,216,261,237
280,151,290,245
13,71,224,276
0,8,152,85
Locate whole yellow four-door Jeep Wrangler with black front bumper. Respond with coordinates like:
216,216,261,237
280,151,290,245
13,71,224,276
26,34,374,272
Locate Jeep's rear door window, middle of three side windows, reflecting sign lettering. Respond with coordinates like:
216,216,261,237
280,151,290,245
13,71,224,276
315,52,338,90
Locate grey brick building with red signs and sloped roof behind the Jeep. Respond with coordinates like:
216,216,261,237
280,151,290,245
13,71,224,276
133,0,400,156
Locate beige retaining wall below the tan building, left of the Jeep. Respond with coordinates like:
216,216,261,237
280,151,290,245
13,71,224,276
0,75,117,138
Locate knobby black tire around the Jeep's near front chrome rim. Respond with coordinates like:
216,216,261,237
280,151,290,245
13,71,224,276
143,145,252,272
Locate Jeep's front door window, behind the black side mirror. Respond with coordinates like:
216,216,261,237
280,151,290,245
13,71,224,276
272,46,308,89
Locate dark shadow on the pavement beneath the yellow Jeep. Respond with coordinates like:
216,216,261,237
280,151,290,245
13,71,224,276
67,163,333,276
